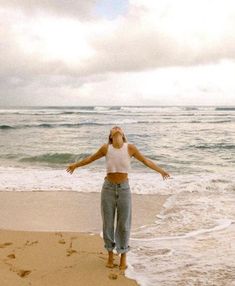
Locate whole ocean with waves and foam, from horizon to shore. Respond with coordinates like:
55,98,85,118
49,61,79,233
0,106,235,286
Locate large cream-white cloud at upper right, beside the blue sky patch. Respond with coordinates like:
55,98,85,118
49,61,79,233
81,0,235,73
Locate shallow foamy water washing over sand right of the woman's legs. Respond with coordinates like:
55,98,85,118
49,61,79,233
126,183,235,286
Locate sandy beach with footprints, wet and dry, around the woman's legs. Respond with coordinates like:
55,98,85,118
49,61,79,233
0,191,167,286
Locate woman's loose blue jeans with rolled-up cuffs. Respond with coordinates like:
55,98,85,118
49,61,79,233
101,177,132,253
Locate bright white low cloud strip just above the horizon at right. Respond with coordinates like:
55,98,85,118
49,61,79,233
68,61,235,105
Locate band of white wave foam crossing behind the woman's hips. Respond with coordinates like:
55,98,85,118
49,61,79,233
0,166,235,195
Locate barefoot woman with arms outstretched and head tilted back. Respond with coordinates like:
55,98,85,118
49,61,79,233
67,126,170,270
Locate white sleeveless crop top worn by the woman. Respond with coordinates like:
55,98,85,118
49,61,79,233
105,142,131,173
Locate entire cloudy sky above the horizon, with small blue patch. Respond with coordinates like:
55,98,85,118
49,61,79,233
0,0,235,107
